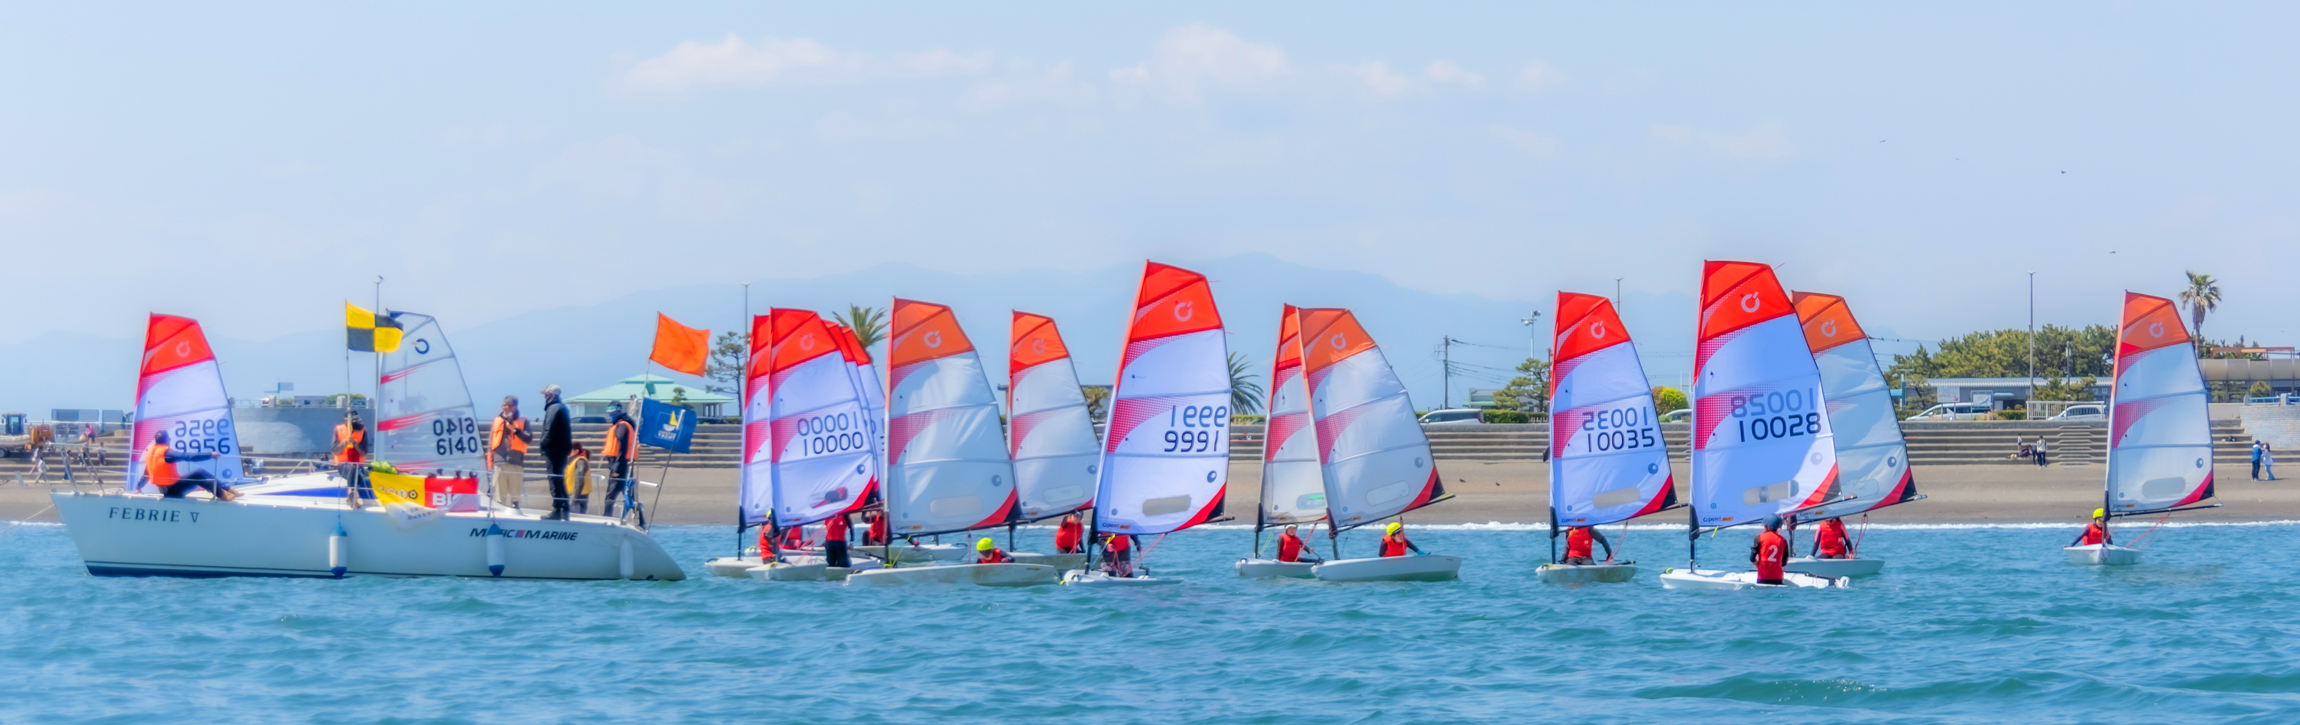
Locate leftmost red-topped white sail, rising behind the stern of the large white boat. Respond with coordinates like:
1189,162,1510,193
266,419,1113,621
127,313,239,493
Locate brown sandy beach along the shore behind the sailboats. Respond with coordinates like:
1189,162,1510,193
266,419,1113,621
0,460,2300,525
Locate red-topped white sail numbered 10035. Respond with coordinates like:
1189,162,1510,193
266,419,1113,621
1550,292,1677,527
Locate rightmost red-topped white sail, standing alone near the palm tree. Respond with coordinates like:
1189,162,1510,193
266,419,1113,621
2107,292,2213,513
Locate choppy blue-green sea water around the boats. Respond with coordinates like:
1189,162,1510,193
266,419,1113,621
0,525,2300,723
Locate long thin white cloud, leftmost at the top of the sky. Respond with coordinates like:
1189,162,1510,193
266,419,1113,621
612,32,991,94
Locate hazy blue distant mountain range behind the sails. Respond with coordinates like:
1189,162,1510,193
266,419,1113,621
0,253,1729,417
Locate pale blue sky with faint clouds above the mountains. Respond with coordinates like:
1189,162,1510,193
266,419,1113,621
0,2,2300,359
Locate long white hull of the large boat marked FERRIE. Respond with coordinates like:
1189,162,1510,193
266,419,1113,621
53,483,685,580
